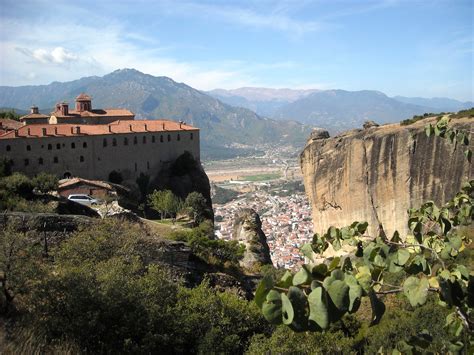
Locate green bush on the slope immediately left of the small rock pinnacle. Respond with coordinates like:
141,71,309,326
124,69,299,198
171,221,245,267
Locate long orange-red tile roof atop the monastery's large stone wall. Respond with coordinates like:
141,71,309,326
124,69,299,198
0,120,199,139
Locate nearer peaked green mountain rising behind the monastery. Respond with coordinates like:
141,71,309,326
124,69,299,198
0,69,311,158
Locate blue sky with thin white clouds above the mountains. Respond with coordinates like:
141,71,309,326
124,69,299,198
0,0,474,101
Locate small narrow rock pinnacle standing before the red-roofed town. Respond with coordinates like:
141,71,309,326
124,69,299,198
232,209,272,269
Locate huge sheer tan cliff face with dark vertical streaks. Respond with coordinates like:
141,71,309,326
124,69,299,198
300,118,474,238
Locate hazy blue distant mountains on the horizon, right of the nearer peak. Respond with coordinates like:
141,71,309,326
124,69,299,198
208,88,474,133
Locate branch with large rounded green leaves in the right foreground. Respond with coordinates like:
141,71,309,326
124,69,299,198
255,180,474,351
